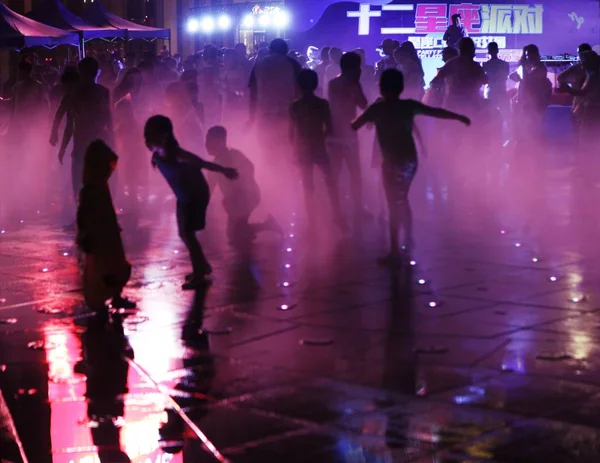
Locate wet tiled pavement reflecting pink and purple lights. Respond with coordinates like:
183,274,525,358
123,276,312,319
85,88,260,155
0,140,600,463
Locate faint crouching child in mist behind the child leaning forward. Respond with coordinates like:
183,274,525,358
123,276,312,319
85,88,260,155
206,125,283,247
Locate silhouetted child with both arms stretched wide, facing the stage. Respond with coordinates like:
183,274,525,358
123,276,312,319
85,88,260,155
352,69,471,265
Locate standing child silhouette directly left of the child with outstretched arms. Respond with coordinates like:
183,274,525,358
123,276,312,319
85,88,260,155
290,69,347,231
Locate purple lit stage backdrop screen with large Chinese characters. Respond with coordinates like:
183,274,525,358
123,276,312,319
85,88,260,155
286,0,600,62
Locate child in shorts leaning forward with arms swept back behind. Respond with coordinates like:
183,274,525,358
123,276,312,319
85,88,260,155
144,116,238,290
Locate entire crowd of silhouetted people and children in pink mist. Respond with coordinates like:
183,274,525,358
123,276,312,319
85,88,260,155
2,34,600,320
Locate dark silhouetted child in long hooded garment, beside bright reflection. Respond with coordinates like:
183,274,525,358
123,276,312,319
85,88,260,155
77,140,135,319
